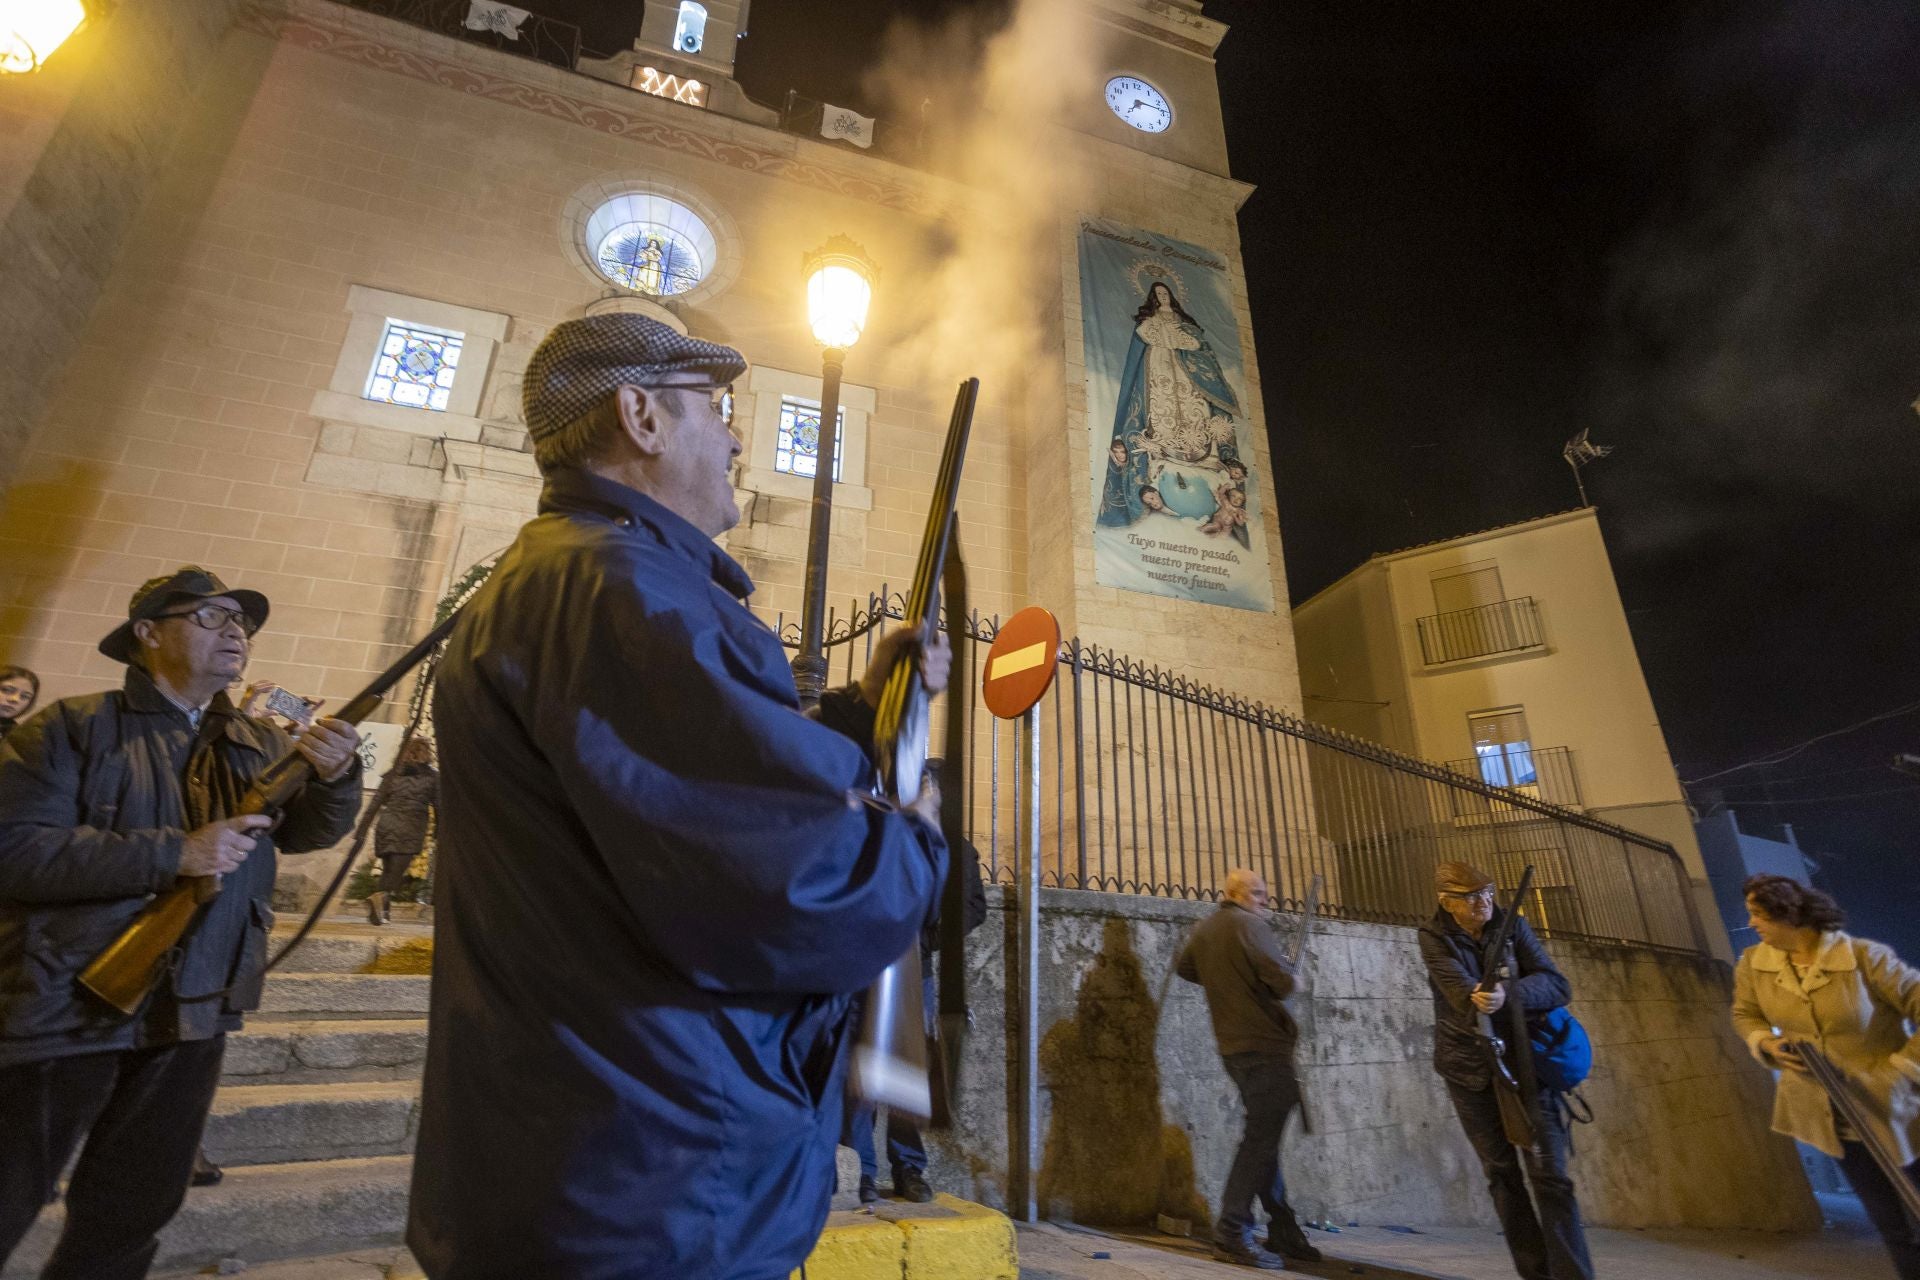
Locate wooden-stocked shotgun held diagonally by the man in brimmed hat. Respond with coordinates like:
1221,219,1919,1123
81,610,461,1015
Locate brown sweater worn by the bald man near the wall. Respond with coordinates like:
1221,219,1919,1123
1175,902,1300,1061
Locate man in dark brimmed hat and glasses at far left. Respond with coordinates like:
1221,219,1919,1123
0,566,361,1278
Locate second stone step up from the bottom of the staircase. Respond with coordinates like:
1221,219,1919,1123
204,1080,420,1165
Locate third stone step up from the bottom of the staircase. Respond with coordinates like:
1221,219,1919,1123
223,1020,426,1084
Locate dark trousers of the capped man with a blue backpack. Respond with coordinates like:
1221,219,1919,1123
1446,1080,1594,1280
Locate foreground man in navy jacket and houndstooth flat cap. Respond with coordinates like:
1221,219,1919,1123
407,315,950,1280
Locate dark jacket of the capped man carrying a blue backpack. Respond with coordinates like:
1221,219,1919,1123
1421,906,1572,1090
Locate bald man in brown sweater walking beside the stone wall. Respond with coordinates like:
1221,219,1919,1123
1175,867,1321,1270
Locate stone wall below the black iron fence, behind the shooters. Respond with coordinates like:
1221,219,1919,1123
910,890,1818,1230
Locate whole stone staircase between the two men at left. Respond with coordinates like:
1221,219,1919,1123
4,921,432,1280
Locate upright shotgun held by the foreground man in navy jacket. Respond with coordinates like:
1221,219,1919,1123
852,378,979,1119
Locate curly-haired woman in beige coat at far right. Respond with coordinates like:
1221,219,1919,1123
1734,875,1920,1280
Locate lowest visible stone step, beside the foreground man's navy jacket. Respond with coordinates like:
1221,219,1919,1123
0,1155,413,1280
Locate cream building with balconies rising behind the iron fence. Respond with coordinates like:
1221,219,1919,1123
1294,507,1732,960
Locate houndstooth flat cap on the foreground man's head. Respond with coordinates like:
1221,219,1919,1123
520,311,747,439
